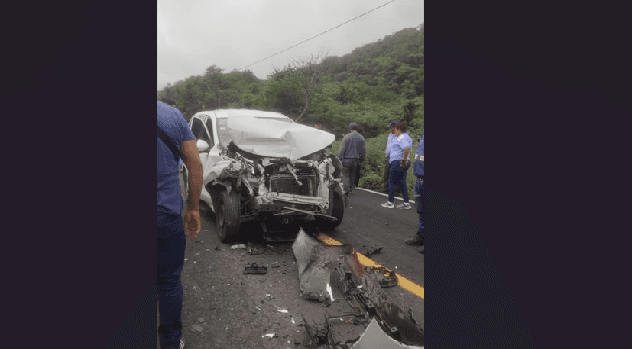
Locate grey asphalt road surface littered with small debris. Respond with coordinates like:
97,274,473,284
158,174,424,349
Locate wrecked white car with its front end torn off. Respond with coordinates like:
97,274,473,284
183,109,344,242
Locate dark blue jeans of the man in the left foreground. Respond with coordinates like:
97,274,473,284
157,213,186,348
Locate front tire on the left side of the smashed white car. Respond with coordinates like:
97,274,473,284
215,189,241,242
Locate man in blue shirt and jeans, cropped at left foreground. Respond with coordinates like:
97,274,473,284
156,102,202,349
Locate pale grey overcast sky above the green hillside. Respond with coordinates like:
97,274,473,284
157,0,424,89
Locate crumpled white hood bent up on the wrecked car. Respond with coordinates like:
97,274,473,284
215,109,335,160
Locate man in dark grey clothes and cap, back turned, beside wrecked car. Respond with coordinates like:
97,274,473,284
338,123,366,196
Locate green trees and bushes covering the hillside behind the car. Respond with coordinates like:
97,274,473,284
158,24,424,193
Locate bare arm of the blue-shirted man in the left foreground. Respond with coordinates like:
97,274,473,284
182,140,202,239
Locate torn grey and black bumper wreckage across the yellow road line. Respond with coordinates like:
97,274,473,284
292,230,424,348
